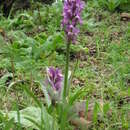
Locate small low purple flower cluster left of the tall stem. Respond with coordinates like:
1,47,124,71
47,67,63,91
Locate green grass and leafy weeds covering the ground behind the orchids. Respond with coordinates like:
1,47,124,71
0,2,130,130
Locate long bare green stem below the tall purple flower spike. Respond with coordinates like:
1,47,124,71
63,43,70,101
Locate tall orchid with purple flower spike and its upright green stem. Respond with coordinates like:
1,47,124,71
62,0,84,100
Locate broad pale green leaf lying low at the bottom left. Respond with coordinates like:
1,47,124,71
2,106,58,130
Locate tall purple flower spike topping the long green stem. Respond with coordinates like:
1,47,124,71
62,0,84,43
